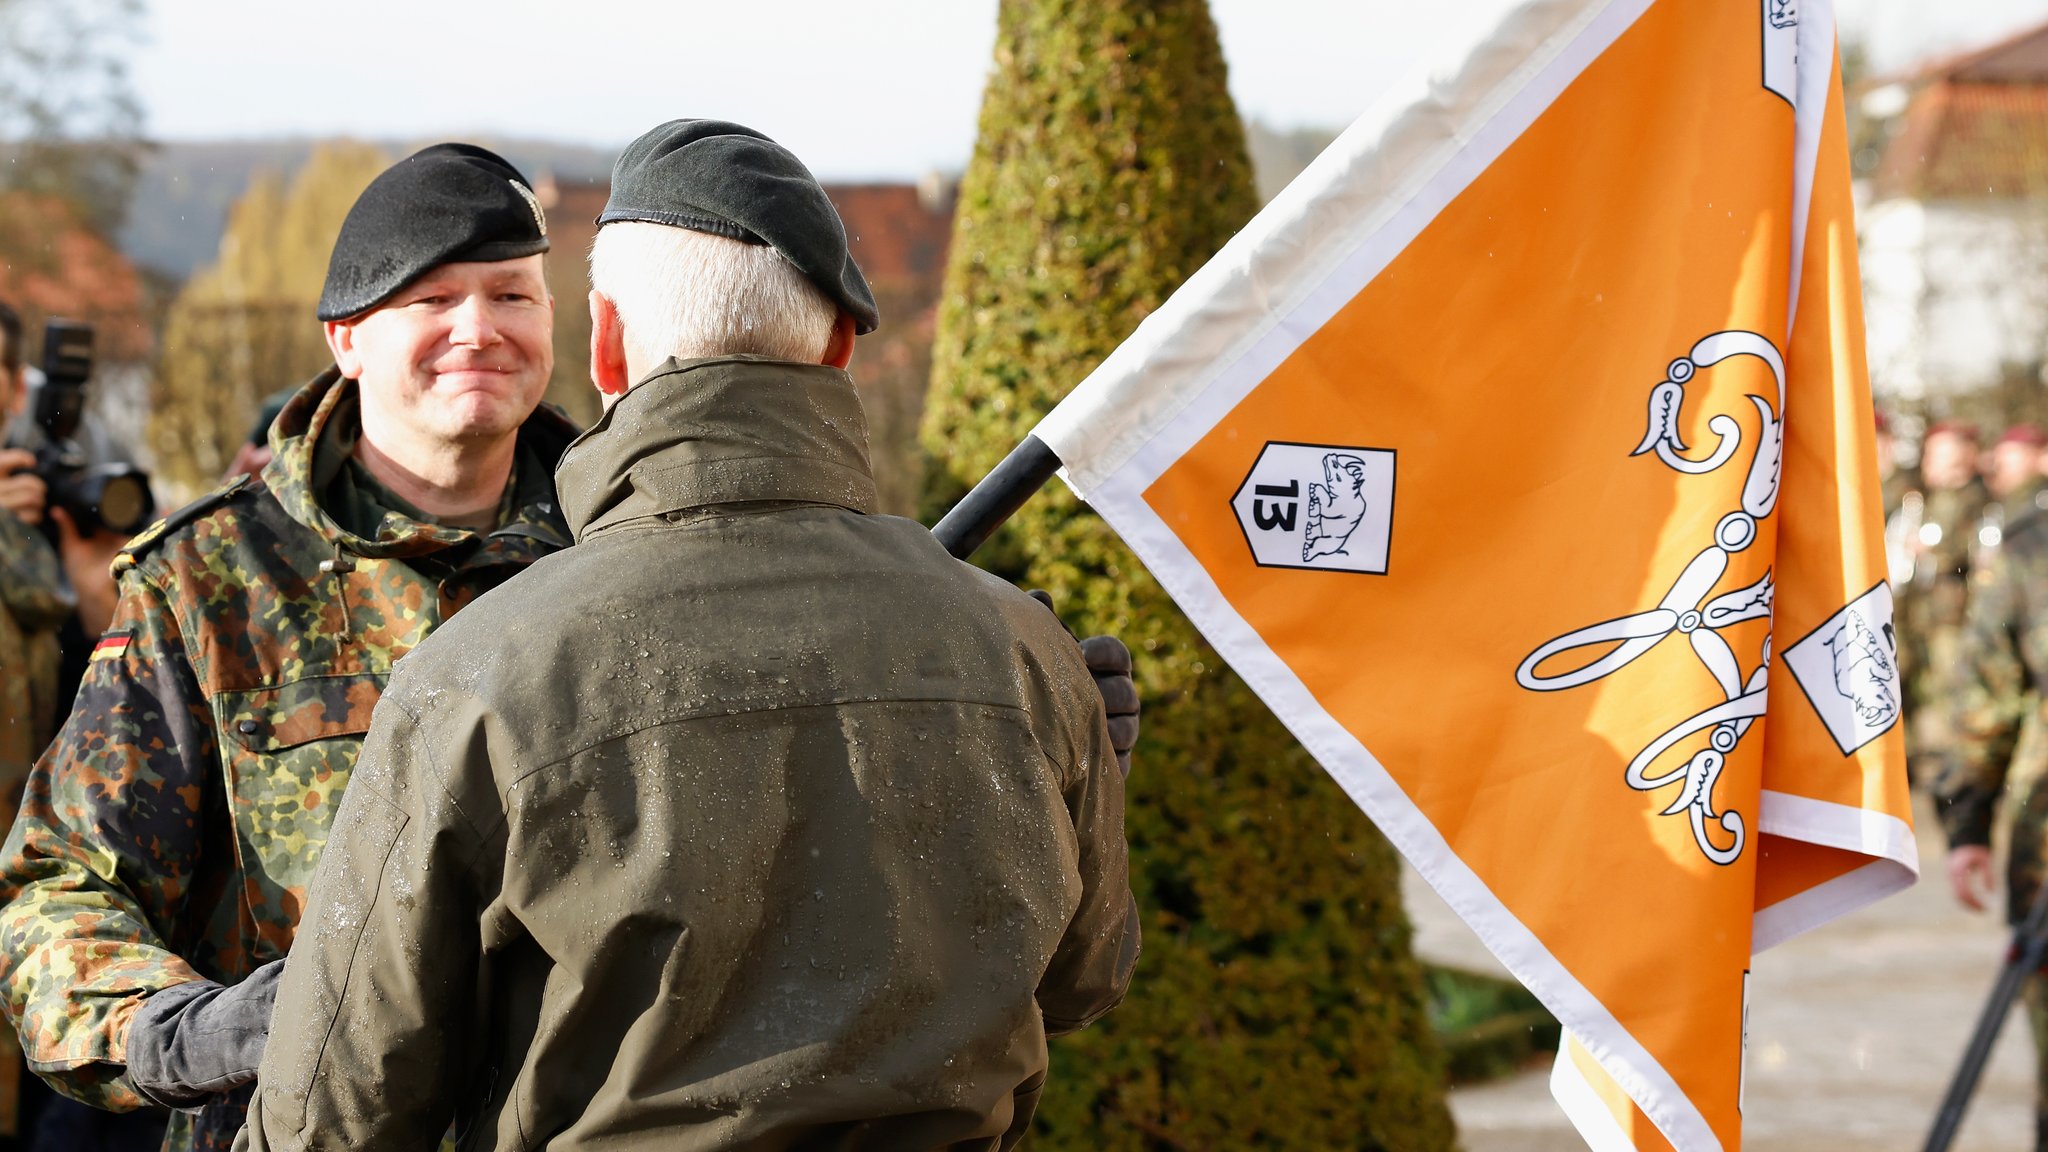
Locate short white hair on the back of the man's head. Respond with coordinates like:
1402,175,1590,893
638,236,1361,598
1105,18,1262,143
590,219,840,365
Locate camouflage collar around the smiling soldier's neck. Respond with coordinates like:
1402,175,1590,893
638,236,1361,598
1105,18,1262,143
262,367,575,558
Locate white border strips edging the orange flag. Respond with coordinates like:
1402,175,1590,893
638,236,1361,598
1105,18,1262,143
1034,0,1917,1152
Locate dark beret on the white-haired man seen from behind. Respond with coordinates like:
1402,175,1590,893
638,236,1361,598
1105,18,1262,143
598,121,881,334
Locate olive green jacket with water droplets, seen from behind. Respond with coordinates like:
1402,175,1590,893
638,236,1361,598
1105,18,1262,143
238,359,1139,1152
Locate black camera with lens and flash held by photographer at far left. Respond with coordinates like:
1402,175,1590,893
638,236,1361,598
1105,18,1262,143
35,320,156,537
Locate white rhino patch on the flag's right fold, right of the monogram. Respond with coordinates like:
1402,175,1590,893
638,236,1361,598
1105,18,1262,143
1786,584,1898,756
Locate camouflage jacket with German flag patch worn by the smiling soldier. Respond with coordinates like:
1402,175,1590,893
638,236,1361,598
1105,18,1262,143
0,369,573,1148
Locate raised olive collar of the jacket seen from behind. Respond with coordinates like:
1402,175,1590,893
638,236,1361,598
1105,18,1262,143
555,357,877,541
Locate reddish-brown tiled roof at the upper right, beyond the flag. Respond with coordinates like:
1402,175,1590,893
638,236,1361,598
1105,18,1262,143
1876,25,2048,201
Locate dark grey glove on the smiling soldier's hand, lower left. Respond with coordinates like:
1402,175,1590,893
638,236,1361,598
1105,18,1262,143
127,959,285,1109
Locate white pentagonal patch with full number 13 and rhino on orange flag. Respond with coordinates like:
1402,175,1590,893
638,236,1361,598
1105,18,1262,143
1231,441,1395,576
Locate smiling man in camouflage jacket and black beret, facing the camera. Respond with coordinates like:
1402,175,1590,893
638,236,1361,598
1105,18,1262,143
0,143,575,1150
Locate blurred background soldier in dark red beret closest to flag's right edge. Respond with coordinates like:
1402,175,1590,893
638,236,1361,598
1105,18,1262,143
1896,420,1991,783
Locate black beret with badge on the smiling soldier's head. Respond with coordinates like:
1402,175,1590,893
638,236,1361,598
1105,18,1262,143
319,143,547,320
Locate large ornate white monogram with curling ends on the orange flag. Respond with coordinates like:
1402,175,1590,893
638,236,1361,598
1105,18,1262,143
1516,332,1786,865
